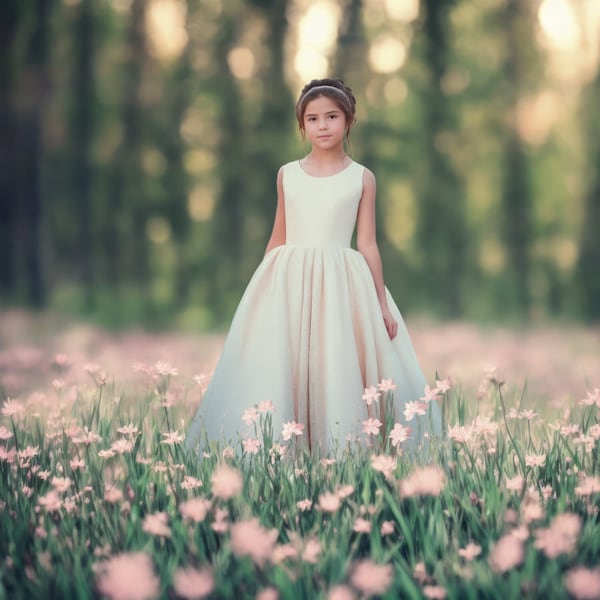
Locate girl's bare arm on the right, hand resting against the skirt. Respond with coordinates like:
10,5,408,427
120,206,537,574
356,169,398,339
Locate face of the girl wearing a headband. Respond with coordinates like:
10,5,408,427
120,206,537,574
303,96,346,150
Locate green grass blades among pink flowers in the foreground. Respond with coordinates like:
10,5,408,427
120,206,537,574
0,371,600,600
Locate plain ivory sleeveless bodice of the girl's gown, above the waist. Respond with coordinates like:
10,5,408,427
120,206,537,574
283,161,364,248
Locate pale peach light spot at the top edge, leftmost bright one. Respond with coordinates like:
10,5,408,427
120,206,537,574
146,0,188,60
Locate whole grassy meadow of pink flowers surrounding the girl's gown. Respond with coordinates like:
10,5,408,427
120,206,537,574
0,314,600,600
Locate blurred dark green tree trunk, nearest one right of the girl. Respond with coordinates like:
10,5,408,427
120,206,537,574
416,0,468,317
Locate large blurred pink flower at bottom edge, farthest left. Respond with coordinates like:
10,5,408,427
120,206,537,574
94,552,160,600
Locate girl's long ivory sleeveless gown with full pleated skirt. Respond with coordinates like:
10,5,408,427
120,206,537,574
186,161,441,454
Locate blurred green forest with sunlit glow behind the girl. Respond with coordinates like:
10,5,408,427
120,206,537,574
0,0,600,330
